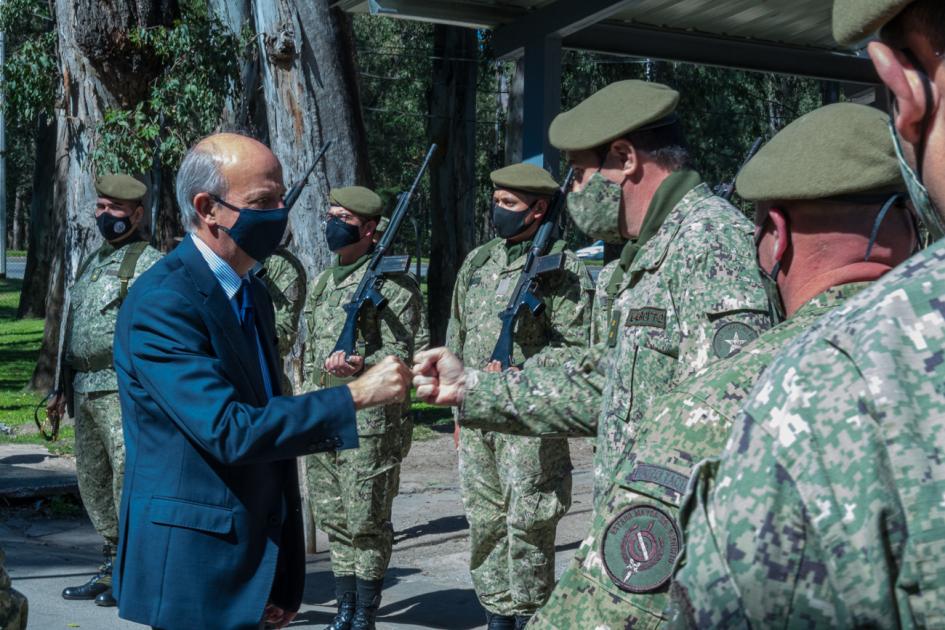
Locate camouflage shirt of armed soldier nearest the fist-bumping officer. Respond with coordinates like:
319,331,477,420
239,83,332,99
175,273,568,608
446,241,592,367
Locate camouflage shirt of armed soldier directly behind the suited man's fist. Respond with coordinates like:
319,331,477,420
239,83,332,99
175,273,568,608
303,256,428,435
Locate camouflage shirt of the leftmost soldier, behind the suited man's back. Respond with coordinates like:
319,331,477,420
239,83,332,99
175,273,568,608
64,241,162,393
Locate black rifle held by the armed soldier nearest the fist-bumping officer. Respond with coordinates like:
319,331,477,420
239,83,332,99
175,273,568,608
490,169,574,370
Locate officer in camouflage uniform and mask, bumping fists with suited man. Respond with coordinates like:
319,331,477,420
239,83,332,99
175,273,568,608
416,81,770,498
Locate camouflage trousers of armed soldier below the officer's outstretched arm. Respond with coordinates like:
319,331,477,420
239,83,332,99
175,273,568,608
459,428,571,615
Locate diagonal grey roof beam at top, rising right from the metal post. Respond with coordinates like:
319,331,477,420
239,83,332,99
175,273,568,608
492,0,640,59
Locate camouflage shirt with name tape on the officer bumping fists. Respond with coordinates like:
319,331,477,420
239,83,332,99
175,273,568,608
461,184,770,504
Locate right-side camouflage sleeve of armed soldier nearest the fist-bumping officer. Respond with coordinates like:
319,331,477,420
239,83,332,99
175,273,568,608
525,251,594,367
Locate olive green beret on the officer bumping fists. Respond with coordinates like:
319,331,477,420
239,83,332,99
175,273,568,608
548,80,679,151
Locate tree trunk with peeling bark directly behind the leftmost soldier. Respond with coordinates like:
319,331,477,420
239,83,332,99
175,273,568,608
27,0,179,390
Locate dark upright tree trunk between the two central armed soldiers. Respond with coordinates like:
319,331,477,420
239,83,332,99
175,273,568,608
427,24,479,345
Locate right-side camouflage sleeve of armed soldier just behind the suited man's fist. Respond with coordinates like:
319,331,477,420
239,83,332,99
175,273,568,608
364,276,423,365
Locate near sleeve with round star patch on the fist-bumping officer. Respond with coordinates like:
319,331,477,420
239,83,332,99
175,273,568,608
672,223,771,383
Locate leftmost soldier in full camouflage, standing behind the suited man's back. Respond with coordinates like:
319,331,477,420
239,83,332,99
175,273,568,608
48,174,161,606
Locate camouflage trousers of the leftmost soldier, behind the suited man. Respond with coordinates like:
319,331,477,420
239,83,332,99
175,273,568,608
75,392,125,547
